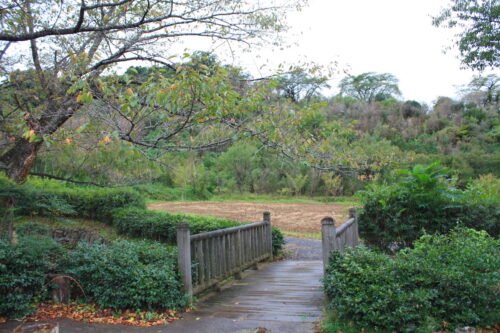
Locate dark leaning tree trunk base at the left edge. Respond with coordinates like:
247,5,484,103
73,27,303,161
0,138,42,184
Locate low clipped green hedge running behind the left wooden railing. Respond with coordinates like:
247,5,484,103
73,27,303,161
113,208,284,254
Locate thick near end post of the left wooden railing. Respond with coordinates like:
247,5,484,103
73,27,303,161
177,222,193,304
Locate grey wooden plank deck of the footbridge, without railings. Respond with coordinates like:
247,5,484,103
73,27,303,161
169,261,323,333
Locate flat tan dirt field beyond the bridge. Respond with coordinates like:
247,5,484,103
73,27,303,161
148,202,349,233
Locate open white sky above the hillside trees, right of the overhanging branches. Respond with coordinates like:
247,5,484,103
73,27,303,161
190,0,496,104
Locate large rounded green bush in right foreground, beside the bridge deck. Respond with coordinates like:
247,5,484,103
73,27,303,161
323,228,500,332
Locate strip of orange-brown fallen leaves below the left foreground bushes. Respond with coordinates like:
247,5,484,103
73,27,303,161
26,302,180,327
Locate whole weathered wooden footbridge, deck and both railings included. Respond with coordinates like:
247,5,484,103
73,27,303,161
169,209,358,333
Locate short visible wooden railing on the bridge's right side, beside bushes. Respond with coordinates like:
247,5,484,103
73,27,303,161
321,208,359,269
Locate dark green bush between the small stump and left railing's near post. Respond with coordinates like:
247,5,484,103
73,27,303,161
61,240,186,310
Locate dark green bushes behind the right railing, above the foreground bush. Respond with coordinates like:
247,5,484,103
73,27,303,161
359,163,500,250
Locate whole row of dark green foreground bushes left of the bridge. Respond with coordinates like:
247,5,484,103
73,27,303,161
0,235,186,318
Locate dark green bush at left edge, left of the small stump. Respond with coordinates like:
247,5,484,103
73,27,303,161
0,236,62,318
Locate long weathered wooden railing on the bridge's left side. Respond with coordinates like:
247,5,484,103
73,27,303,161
177,212,273,302
